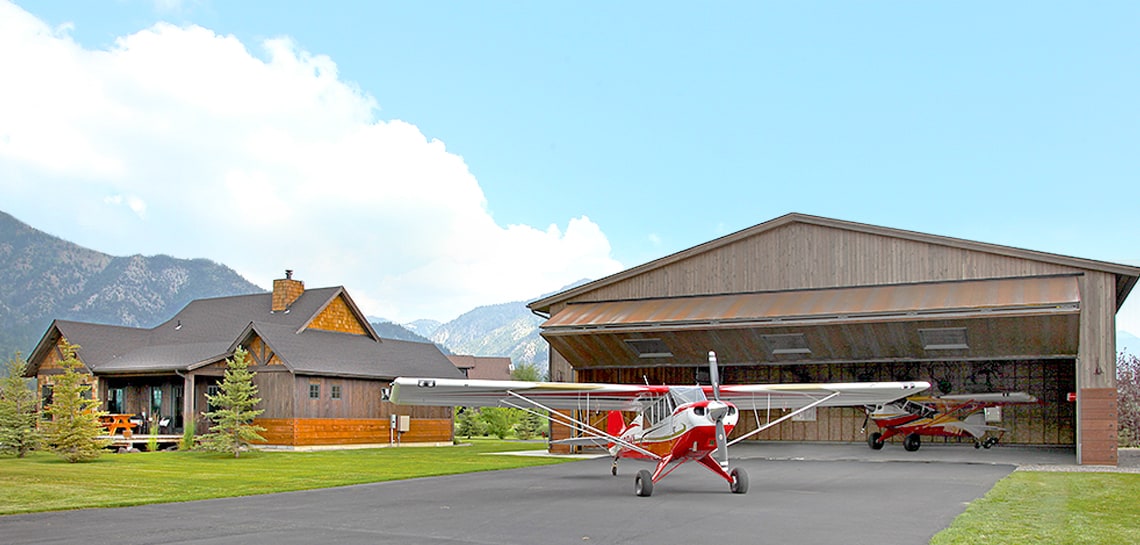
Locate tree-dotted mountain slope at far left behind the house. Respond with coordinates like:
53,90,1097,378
0,212,264,358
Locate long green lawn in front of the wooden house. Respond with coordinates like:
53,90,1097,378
0,440,561,514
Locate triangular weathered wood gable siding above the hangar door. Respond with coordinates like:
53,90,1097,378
570,223,1085,311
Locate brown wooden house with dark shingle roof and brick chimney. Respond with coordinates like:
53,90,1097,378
27,270,463,447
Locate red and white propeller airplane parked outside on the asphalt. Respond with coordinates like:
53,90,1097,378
390,352,930,496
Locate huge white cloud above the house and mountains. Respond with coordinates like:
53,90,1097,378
0,0,620,319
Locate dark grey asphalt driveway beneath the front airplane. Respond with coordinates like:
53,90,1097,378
0,449,1015,545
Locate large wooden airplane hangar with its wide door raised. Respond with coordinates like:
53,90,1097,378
529,214,1140,464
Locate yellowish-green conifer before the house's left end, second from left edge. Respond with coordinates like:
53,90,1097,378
44,339,111,463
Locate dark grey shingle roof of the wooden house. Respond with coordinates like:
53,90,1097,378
29,282,462,379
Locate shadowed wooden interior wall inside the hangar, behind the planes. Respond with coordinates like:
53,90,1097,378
579,359,1075,445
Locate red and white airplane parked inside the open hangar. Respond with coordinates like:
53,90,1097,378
863,392,1037,452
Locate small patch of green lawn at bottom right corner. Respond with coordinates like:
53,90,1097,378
930,471,1140,545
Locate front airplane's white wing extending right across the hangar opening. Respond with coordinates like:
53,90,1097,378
706,381,930,410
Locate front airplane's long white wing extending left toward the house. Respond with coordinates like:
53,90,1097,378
390,376,669,410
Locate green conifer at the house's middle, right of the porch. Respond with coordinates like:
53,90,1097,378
201,347,266,458
